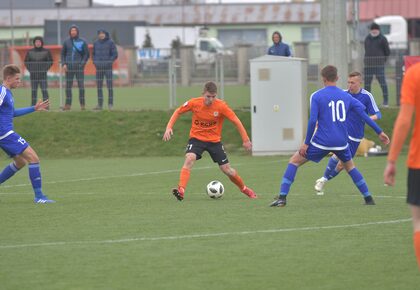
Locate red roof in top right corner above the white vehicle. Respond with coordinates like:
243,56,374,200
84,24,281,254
359,0,420,21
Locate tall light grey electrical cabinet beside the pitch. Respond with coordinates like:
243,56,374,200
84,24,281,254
250,55,309,155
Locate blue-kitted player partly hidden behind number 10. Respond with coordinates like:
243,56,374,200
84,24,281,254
315,72,382,195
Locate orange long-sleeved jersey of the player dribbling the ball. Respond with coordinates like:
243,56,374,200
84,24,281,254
166,97,249,142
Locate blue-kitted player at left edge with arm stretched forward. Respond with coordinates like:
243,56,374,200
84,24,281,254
0,64,54,203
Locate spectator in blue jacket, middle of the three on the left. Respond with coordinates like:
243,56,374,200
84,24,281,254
61,25,89,111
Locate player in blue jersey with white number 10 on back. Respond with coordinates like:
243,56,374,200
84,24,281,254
271,65,389,207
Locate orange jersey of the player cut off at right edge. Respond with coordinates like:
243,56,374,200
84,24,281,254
401,63,420,169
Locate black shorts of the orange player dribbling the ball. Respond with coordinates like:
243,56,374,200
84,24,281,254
185,138,229,165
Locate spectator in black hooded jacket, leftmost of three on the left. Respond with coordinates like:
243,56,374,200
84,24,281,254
25,36,53,106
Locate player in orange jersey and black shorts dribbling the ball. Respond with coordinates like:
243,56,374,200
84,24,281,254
163,82,257,201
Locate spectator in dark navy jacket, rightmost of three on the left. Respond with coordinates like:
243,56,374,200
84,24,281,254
92,29,118,110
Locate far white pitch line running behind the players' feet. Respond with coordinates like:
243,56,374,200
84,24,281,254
1,159,288,188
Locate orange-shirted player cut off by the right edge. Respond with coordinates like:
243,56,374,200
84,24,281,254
384,63,420,267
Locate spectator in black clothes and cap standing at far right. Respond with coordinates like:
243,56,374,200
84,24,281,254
364,22,390,107
